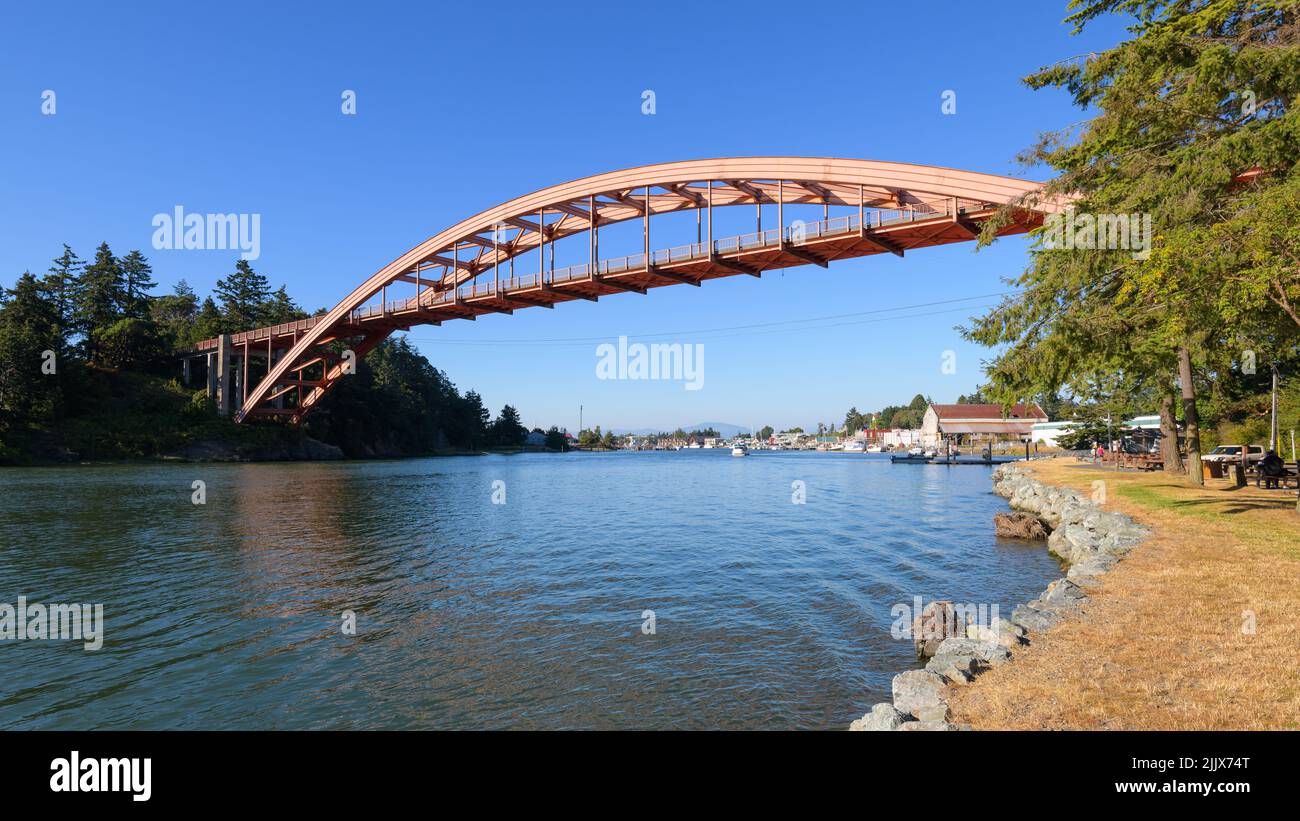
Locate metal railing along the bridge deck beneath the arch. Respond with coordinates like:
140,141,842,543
352,200,995,320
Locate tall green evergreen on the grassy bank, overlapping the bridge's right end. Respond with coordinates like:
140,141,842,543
967,0,1300,483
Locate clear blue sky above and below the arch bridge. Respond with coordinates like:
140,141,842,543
0,0,1123,429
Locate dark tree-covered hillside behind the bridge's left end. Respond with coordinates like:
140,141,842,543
0,243,538,464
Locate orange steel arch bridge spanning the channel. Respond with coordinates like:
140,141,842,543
185,157,1061,422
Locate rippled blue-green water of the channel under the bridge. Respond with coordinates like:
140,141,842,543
0,451,1058,729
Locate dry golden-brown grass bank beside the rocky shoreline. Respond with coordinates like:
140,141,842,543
952,460,1300,730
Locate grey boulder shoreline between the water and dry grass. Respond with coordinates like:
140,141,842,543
849,464,1151,730
